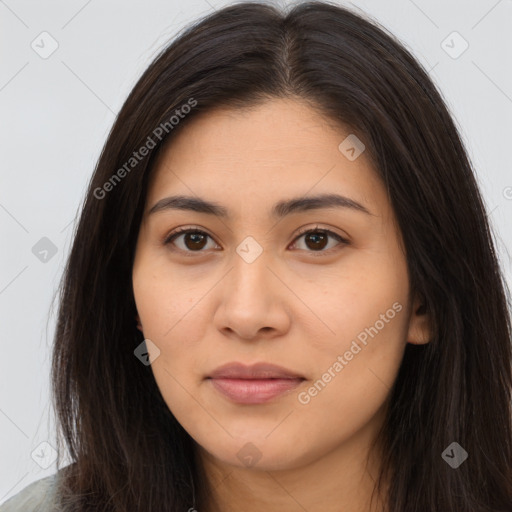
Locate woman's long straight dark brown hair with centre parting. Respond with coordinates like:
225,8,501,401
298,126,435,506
52,2,512,512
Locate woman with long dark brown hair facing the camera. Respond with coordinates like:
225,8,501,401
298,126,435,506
2,2,512,512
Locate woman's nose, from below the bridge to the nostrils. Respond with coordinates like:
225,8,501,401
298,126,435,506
214,252,293,340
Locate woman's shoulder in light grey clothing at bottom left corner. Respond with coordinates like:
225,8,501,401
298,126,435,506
0,472,58,512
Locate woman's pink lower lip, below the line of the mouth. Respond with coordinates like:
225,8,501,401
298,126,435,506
209,379,304,404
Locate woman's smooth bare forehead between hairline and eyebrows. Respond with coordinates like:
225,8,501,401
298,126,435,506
147,99,387,221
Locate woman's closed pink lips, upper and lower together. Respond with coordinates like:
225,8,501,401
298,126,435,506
207,363,305,404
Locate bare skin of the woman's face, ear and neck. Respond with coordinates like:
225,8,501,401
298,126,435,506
132,99,430,512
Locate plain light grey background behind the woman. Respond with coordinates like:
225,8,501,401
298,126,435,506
0,0,512,503
